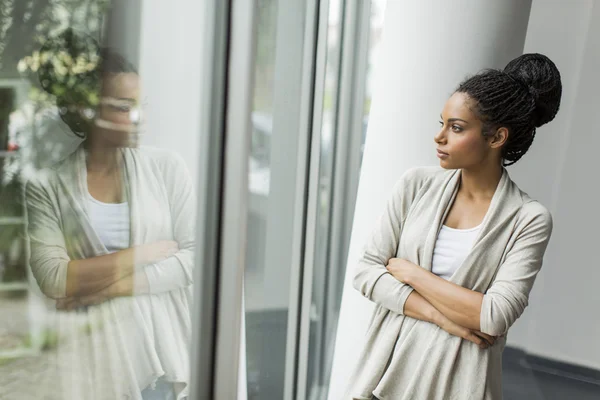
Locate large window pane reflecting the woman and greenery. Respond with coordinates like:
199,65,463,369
0,0,203,400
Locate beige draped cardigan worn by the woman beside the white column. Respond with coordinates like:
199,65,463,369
344,167,552,400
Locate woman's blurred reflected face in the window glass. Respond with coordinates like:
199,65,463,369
93,73,140,147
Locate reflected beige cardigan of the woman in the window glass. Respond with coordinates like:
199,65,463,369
26,146,196,400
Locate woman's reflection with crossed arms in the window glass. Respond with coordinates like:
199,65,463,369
26,31,196,400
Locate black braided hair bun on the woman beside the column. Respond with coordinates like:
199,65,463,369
504,53,562,127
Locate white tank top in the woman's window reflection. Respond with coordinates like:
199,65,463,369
88,193,129,253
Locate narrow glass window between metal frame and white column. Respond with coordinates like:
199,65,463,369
306,0,385,399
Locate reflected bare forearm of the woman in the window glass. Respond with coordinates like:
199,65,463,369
66,248,136,297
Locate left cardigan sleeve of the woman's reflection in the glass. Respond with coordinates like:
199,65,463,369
25,176,70,299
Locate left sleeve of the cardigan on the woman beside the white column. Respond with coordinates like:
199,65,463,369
353,169,418,314
